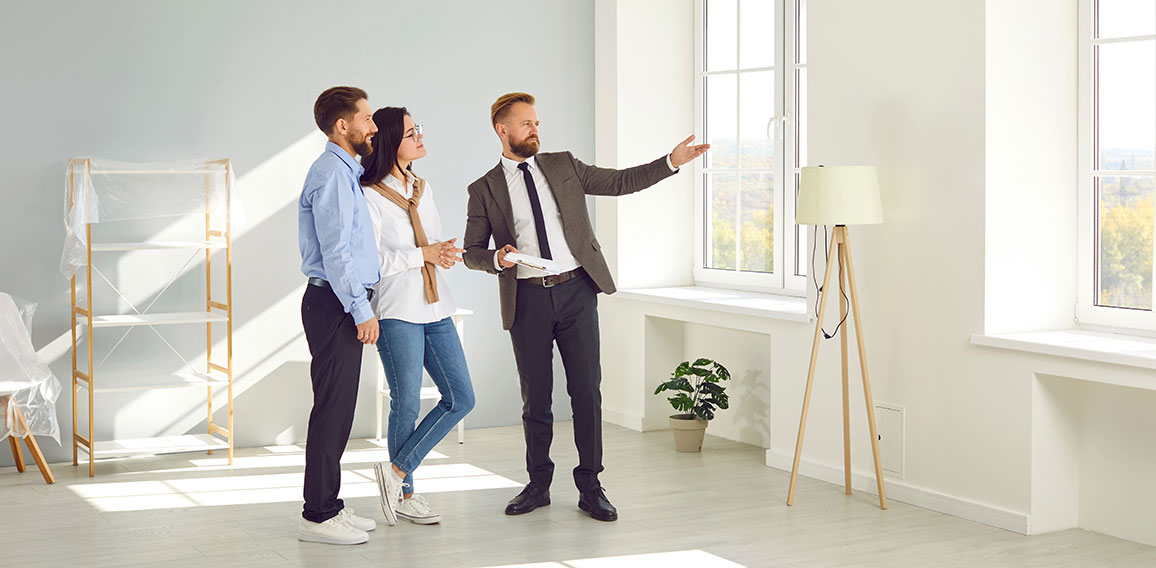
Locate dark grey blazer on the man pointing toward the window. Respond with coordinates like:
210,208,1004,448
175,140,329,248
462,152,674,330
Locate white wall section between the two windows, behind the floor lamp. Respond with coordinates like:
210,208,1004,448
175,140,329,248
799,0,1030,510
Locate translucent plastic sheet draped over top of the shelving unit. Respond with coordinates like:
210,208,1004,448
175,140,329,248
60,157,242,278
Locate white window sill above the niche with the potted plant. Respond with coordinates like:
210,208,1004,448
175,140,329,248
609,286,810,323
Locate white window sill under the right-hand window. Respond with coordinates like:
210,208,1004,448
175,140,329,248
971,330,1156,369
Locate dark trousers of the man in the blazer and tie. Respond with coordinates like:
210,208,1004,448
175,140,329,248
510,274,602,490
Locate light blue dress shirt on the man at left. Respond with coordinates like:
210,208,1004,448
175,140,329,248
297,141,380,323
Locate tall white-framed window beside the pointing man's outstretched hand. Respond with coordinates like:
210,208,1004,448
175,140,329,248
694,0,808,294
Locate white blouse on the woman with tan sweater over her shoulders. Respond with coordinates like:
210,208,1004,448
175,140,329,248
363,174,457,324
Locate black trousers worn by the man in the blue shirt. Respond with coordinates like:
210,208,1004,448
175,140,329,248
301,286,364,523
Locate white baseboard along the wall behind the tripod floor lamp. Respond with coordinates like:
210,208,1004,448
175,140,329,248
766,450,1031,534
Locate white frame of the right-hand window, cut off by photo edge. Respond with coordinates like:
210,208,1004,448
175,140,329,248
1075,0,1156,333
